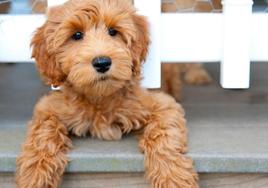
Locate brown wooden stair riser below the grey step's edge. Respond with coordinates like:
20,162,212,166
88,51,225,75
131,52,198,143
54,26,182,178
0,173,268,188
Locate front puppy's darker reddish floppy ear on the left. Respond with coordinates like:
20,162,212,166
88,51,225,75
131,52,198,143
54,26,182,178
31,8,65,86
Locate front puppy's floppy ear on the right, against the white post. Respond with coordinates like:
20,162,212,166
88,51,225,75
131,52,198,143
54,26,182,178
132,15,150,75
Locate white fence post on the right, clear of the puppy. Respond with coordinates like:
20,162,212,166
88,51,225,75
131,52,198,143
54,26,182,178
221,0,253,88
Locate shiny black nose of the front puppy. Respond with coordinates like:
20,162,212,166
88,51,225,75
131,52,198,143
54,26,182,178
92,56,112,73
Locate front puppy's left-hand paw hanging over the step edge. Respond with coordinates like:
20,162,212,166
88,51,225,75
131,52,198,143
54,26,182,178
16,152,67,188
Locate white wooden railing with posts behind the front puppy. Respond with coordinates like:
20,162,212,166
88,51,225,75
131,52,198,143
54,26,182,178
0,0,268,88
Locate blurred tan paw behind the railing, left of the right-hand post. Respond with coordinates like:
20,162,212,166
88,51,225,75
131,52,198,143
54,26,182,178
184,69,212,85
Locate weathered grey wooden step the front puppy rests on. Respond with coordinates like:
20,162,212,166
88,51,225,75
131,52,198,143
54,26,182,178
0,64,268,172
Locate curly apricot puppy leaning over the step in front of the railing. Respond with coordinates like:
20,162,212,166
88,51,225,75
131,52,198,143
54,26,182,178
16,0,198,188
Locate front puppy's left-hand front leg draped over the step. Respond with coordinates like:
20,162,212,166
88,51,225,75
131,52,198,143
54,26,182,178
16,115,72,188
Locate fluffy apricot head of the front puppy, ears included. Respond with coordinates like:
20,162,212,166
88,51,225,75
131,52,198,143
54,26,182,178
32,0,149,96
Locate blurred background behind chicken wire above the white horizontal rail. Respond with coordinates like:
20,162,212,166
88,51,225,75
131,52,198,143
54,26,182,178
0,0,268,14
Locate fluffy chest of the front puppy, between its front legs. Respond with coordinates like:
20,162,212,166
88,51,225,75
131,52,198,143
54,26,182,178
60,97,148,137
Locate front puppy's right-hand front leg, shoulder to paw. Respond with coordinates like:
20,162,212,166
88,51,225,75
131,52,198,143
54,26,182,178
139,93,198,188
